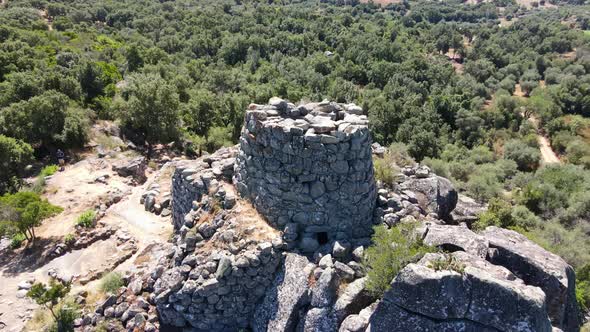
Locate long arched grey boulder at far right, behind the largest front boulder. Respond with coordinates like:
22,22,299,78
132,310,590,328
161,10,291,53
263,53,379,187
482,226,580,332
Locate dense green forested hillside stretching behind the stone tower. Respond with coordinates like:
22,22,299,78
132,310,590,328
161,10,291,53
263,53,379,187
0,0,590,318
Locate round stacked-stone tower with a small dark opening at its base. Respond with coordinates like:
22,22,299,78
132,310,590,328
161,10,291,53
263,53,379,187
233,98,376,252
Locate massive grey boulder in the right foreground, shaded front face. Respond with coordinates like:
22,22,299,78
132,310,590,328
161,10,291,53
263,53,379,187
370,253,552,332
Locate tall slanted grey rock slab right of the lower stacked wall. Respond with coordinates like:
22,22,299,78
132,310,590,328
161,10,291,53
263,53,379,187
252,254,310,332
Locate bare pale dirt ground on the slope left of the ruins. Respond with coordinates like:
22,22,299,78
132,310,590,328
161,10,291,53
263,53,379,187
0,156,172,332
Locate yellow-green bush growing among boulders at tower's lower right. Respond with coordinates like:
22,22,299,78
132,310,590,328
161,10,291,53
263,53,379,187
363,223,434,297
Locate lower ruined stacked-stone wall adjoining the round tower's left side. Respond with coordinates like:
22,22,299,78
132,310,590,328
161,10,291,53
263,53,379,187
162,147,284,331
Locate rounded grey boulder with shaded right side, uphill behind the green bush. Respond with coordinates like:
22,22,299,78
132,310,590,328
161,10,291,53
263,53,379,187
402,175,457,220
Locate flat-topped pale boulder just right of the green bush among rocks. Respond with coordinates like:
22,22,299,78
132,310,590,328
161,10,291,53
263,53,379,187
424,224,488,258
